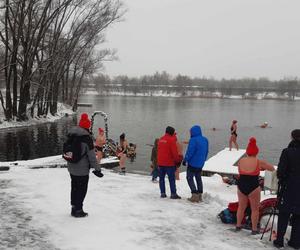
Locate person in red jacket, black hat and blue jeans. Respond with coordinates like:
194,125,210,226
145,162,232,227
157,126,183,199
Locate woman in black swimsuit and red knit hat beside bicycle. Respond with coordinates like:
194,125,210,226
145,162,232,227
236,137,275,234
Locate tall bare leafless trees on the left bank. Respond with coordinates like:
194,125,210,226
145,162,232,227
0,0,124,121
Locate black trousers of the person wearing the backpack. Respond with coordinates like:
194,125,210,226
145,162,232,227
70,174,89,211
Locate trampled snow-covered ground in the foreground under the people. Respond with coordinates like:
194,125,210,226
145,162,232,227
0,159,273,250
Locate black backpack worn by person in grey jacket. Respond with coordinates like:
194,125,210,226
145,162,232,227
62,135,87,163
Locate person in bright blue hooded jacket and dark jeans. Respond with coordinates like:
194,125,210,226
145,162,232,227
183,125,208,202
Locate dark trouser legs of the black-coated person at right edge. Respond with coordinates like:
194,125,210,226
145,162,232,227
277,212,300,247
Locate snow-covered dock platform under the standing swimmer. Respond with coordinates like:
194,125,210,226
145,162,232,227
203,148,246,175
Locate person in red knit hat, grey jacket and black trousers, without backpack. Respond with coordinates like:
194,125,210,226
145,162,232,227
67,113,101,217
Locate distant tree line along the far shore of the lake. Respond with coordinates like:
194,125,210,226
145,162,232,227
94,71,300,99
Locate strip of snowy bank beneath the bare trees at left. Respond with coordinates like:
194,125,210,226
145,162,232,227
0,103,74,129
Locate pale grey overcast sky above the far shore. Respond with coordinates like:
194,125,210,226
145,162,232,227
105,0,300,79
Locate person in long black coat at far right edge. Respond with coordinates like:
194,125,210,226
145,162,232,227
273,129,300,249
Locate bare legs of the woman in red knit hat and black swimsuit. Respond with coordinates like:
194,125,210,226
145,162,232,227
236,187,260,231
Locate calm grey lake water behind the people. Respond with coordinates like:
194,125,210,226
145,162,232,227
0,96,300,173
